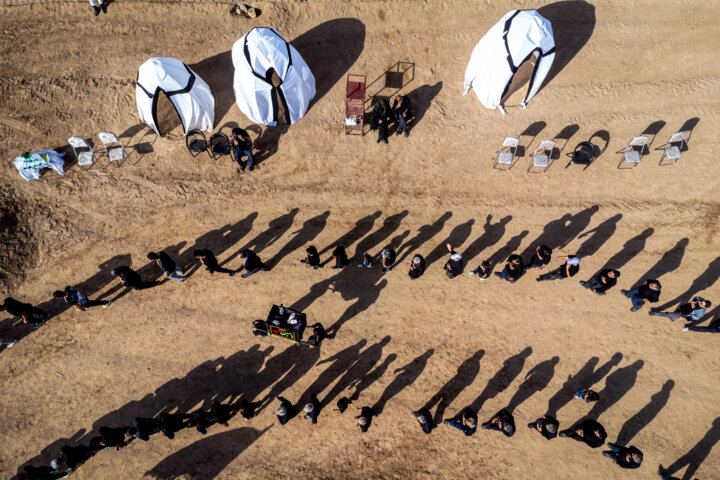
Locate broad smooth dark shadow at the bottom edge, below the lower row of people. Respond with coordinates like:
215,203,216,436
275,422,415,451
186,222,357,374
145,425,272,480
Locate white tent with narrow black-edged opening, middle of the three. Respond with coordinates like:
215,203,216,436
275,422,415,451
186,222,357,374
232,28,315,126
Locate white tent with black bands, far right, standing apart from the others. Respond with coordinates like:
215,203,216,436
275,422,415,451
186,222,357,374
463,10,555,113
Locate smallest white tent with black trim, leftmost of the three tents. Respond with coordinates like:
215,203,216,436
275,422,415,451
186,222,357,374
135,57,215,135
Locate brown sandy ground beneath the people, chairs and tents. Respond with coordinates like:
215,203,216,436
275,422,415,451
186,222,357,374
0,0,720,479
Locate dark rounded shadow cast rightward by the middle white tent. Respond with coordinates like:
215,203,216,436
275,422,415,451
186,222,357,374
290,18,365,110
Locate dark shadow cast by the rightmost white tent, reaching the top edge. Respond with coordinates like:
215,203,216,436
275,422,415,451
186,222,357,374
537,0,595,90
